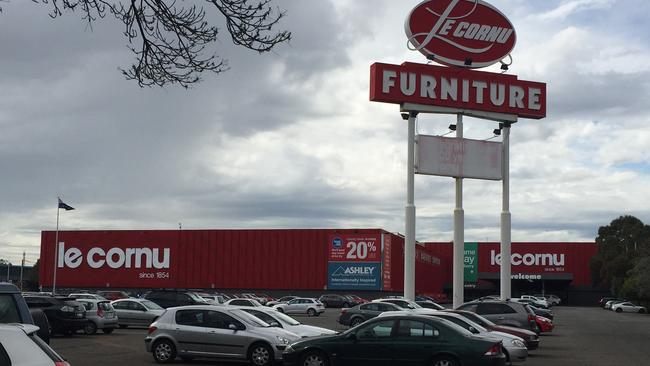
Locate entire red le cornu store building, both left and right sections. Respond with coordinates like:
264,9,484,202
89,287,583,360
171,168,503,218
40,229,602,303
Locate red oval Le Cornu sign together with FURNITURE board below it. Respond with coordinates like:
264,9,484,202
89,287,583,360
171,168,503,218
370,0,546,119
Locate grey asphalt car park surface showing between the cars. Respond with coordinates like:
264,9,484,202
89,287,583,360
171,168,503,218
51,307,650,366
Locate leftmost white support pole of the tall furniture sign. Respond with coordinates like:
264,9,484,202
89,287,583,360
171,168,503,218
404,112,417,300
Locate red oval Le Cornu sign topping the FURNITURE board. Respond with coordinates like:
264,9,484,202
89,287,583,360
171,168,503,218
405,0,517,69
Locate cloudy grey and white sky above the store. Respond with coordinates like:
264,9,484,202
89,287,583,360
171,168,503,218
0,0,650,264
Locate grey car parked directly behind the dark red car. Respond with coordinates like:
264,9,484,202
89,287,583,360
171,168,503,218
450,300,540,334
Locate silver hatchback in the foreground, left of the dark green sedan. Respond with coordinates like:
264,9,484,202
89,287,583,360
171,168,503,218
145,305,300,366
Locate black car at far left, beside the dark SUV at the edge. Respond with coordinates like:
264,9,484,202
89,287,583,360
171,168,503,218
25,295,87,335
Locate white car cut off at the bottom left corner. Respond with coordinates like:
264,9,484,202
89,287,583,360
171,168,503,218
0,324,70,366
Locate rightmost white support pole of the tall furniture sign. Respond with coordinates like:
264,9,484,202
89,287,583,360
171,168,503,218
501,123,512,300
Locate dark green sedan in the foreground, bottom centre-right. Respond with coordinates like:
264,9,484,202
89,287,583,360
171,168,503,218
283,315,506,366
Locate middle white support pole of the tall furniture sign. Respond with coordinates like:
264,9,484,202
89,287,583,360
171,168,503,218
453,113,465,309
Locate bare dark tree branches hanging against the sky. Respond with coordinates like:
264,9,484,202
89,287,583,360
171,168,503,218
15,0,291,87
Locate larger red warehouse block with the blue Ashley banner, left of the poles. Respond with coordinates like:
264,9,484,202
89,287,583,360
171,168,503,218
40,229,444,293
